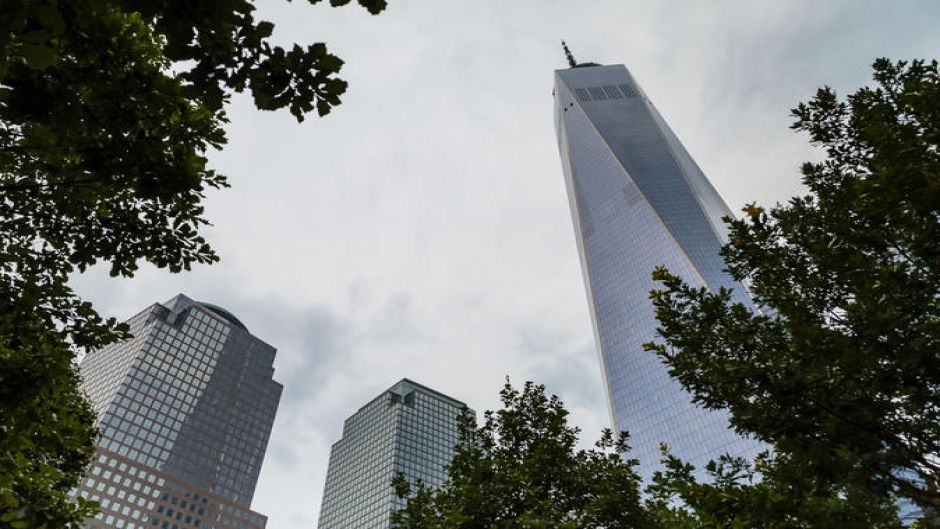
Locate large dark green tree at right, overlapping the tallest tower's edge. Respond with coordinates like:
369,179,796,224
648,59,940,510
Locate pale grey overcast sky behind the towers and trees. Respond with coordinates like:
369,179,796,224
75,0,940,529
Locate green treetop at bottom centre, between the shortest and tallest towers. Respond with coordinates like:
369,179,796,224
393,382,653,529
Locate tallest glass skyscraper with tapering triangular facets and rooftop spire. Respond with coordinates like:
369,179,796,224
554,48,758,476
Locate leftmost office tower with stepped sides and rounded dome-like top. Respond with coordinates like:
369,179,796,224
74,295,281,529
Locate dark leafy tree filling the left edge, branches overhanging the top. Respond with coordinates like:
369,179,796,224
0,0,386,527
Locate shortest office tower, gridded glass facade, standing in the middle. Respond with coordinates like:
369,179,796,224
318,378,464,529
